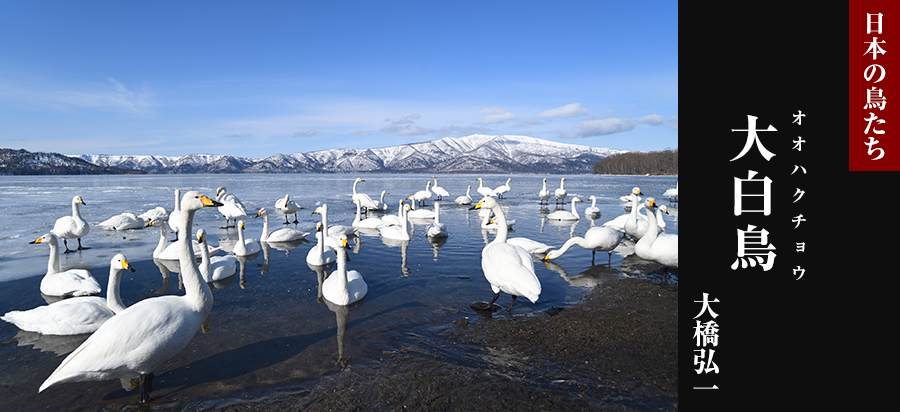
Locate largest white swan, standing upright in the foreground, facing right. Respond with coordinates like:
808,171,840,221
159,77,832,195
38,191,220,403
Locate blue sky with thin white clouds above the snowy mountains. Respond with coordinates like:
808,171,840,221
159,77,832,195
0,0,678,157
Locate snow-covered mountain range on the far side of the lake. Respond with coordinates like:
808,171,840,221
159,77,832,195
73,135,626,173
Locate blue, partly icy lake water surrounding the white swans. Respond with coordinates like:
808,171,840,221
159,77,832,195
0,174,678,410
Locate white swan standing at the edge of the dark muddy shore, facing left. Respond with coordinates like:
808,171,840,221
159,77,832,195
473,197,541,313
